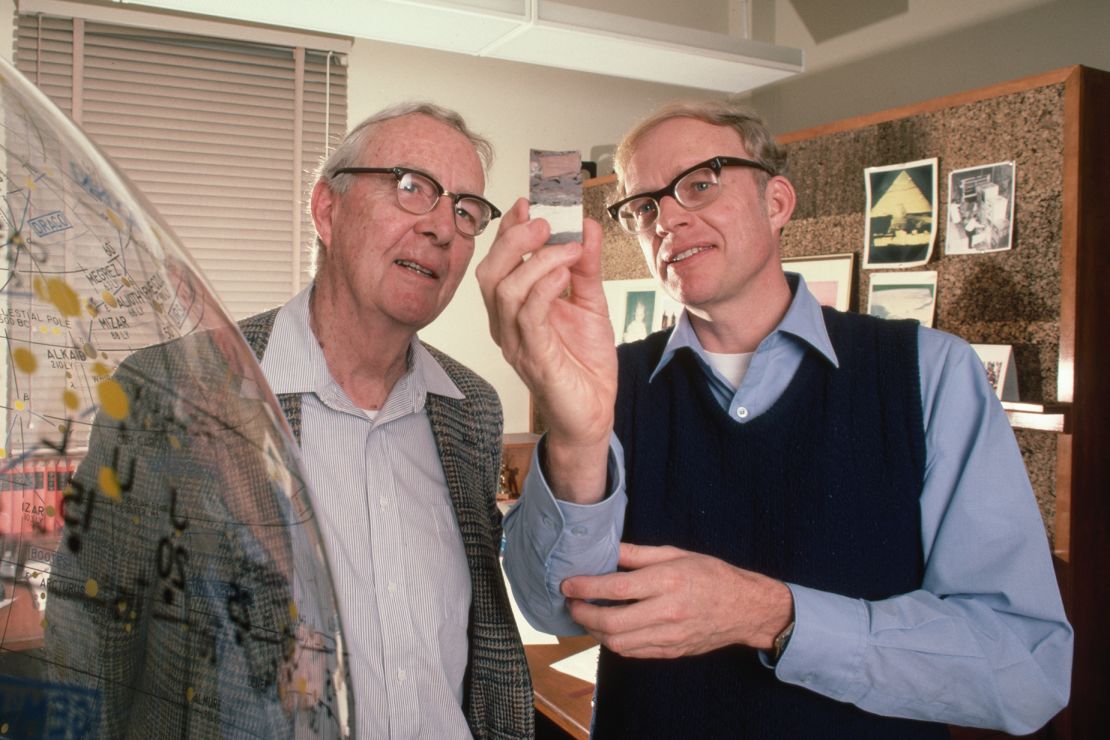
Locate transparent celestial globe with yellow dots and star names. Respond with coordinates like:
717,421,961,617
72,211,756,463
0,59,354,738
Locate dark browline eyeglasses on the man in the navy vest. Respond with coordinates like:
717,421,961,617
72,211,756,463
608,156,775,234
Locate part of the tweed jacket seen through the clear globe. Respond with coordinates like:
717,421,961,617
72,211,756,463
43,325,317,738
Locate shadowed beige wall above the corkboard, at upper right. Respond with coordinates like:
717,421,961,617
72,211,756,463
750,0,1110,132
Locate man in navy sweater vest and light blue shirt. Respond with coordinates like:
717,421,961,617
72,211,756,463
478,102,1072,738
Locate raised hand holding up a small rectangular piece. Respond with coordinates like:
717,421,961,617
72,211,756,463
476,199,617,503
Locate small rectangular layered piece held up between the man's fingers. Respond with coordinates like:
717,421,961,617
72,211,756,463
528,149,582,244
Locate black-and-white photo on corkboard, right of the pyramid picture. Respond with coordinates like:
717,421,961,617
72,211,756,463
945,162,1016,254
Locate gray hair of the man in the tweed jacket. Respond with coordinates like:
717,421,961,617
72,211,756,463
312,100,493,273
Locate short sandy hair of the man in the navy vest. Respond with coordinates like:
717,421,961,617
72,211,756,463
613,100,786,195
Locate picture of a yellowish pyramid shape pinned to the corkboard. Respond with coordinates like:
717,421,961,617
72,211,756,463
864,158,937,268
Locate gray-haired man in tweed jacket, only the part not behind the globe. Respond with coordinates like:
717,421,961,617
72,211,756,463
242,104,533,738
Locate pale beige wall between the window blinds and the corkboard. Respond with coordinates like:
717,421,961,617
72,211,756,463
347,40,706,432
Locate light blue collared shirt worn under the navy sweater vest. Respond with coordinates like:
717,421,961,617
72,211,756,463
505,273,1072,734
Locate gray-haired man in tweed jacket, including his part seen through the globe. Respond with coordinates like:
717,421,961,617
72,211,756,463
42,104,534,740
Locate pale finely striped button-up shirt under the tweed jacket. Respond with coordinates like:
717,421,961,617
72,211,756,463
261,287,471,739
